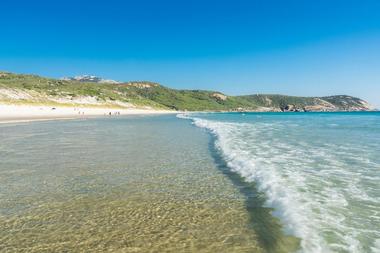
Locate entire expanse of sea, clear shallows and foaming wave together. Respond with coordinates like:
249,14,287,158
0,112,380,252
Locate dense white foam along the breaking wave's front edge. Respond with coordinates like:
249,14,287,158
178,114,378,252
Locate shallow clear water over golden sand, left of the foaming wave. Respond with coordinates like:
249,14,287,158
0,115,299,252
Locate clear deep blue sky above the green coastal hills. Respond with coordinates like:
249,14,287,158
0,0,380,107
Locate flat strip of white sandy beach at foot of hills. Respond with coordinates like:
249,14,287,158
0,104,175,123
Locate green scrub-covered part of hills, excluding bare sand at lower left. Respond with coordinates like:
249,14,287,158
0,72,370,111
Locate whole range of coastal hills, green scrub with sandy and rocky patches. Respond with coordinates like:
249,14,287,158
0,72,374,112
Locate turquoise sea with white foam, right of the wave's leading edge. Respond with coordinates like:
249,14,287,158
178,112,380,252
